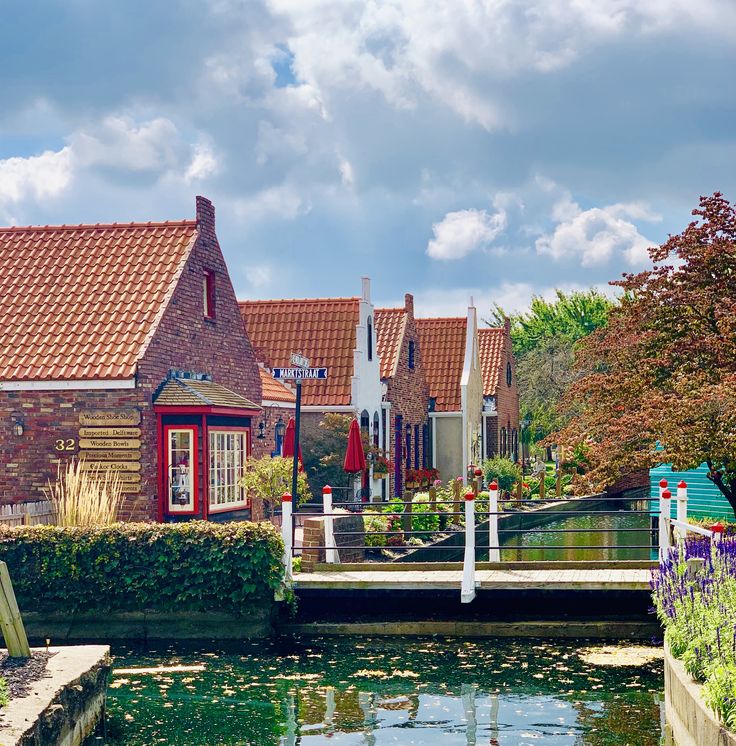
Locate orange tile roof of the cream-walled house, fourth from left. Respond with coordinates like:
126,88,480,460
416,318,468,412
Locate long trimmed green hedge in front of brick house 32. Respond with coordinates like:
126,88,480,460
0,521,283,613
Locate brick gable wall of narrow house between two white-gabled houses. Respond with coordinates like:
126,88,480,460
386,293,431,497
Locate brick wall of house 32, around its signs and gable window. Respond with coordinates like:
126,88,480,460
0,197,261,520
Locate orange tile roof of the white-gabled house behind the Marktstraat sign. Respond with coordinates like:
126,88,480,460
240,298,360,407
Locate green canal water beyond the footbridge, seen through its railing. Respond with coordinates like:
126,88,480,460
500,508,657,562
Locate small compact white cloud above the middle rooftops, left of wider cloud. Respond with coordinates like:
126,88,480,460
427,210,506,260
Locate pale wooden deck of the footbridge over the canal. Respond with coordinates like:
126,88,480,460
294,567,651,591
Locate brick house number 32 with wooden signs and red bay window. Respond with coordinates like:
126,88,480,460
0,197,261,520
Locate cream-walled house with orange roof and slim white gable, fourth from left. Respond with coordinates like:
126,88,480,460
416,300,483,481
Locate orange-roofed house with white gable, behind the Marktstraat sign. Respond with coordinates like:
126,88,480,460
240,278,386,498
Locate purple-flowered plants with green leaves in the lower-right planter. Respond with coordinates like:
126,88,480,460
652,536,736,730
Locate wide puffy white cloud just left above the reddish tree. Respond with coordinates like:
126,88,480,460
536,196,658,267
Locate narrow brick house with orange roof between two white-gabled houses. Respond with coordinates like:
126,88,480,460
375,293,429,499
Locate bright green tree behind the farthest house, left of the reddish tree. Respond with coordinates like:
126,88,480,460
487,288,615,443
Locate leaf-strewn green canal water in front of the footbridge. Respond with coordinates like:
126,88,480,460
87,638,662,746
